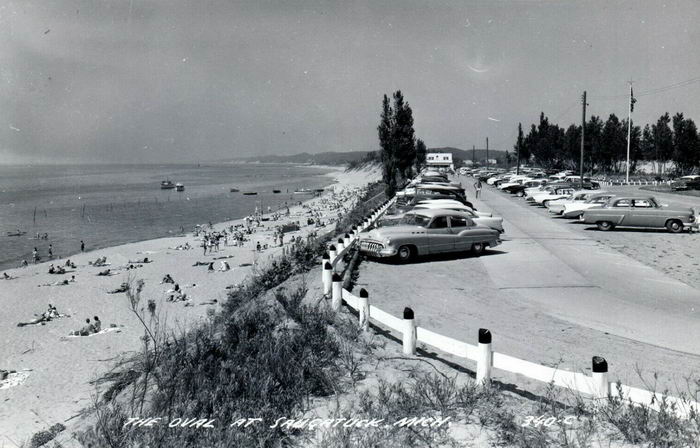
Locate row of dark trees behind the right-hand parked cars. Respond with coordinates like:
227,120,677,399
509,112,700,174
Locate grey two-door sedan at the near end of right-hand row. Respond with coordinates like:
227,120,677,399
579,196,698,233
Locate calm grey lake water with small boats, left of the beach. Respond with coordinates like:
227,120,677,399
0,164,331,270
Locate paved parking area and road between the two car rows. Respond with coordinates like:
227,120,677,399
358,177,700,390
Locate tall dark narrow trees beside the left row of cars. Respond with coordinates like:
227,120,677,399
377,90,426,196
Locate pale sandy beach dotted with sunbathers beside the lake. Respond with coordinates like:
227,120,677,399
0,164,380,446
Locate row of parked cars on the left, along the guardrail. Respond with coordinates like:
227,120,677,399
360,171,504,262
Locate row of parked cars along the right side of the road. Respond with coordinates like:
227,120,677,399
492,173,698,233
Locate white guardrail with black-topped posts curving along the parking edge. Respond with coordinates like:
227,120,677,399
321,199,700,418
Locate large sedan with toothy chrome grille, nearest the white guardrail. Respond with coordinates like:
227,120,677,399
360,209,501,262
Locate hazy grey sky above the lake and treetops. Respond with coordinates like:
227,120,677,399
0,0,700,163
